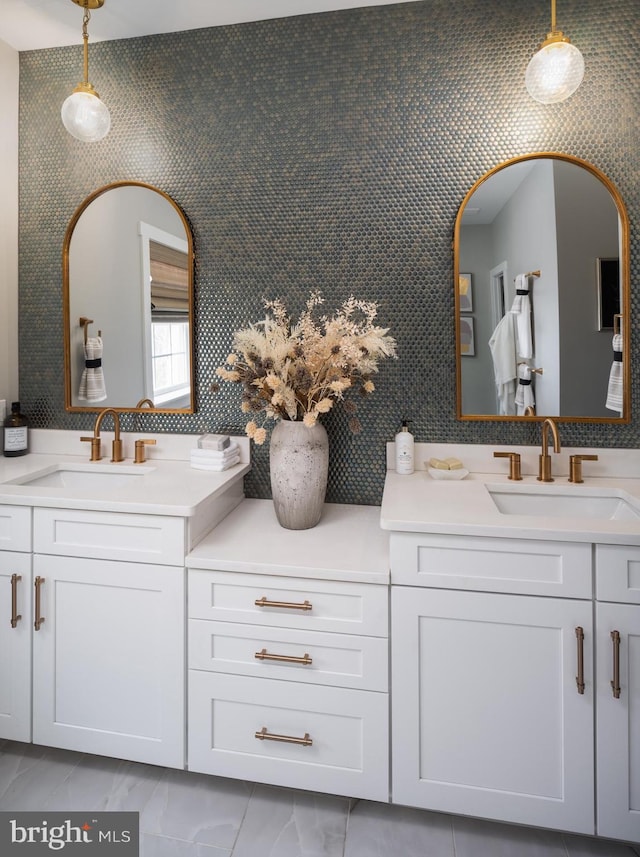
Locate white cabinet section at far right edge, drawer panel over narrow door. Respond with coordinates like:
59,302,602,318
595,545,640,842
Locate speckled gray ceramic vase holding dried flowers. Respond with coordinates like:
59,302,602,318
269,420,329,530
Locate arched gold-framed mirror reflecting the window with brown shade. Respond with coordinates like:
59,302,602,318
62,182,195,413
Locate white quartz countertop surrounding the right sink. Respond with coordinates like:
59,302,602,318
380,470,640,545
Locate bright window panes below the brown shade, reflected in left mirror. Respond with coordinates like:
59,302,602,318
151,316,189,405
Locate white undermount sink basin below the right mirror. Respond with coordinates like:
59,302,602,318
487,485,640,521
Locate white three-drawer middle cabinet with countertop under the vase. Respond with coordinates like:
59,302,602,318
187,500,389,801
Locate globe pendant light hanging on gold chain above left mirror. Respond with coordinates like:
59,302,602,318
61,0,111,143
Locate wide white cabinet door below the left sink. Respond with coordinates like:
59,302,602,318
33,555,185,767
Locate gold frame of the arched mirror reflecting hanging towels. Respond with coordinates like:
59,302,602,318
453,152,631,424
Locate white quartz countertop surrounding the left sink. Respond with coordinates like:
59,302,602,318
0,448,250,517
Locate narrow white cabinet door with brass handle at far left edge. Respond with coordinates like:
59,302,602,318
0,551,31,741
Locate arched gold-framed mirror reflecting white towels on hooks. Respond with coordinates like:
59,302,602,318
454,153,631,422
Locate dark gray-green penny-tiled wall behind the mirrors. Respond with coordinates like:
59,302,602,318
20,0,640,503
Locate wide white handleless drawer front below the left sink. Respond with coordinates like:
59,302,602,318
33,509,185,566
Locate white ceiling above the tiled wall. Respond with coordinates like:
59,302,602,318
0,0,424,51
